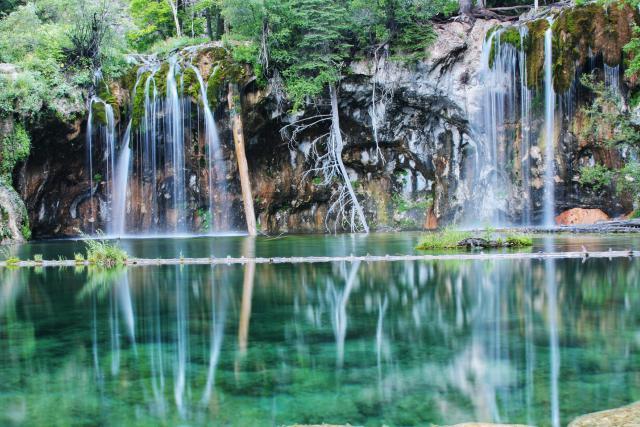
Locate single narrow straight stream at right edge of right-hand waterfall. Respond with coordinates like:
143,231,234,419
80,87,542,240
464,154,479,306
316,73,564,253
543,20,556,227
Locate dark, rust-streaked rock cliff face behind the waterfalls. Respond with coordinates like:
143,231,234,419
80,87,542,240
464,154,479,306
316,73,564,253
6,7,631,241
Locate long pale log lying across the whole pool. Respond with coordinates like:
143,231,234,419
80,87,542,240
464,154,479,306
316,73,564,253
0,250,640,267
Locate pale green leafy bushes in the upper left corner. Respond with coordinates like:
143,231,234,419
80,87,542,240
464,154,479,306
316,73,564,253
0,0,129,120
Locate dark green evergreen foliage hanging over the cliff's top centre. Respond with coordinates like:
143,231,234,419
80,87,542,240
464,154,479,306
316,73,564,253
223,0,457,109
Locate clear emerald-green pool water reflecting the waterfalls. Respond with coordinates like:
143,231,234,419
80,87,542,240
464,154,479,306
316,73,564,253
0,234,640,426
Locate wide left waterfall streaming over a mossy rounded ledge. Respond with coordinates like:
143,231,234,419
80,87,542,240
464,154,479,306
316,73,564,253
87,54,230,236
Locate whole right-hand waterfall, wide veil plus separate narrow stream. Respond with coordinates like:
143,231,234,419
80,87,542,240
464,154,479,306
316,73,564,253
470,19,560,226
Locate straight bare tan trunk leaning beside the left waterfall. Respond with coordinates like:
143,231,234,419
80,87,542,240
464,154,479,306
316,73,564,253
227,83,257,236
